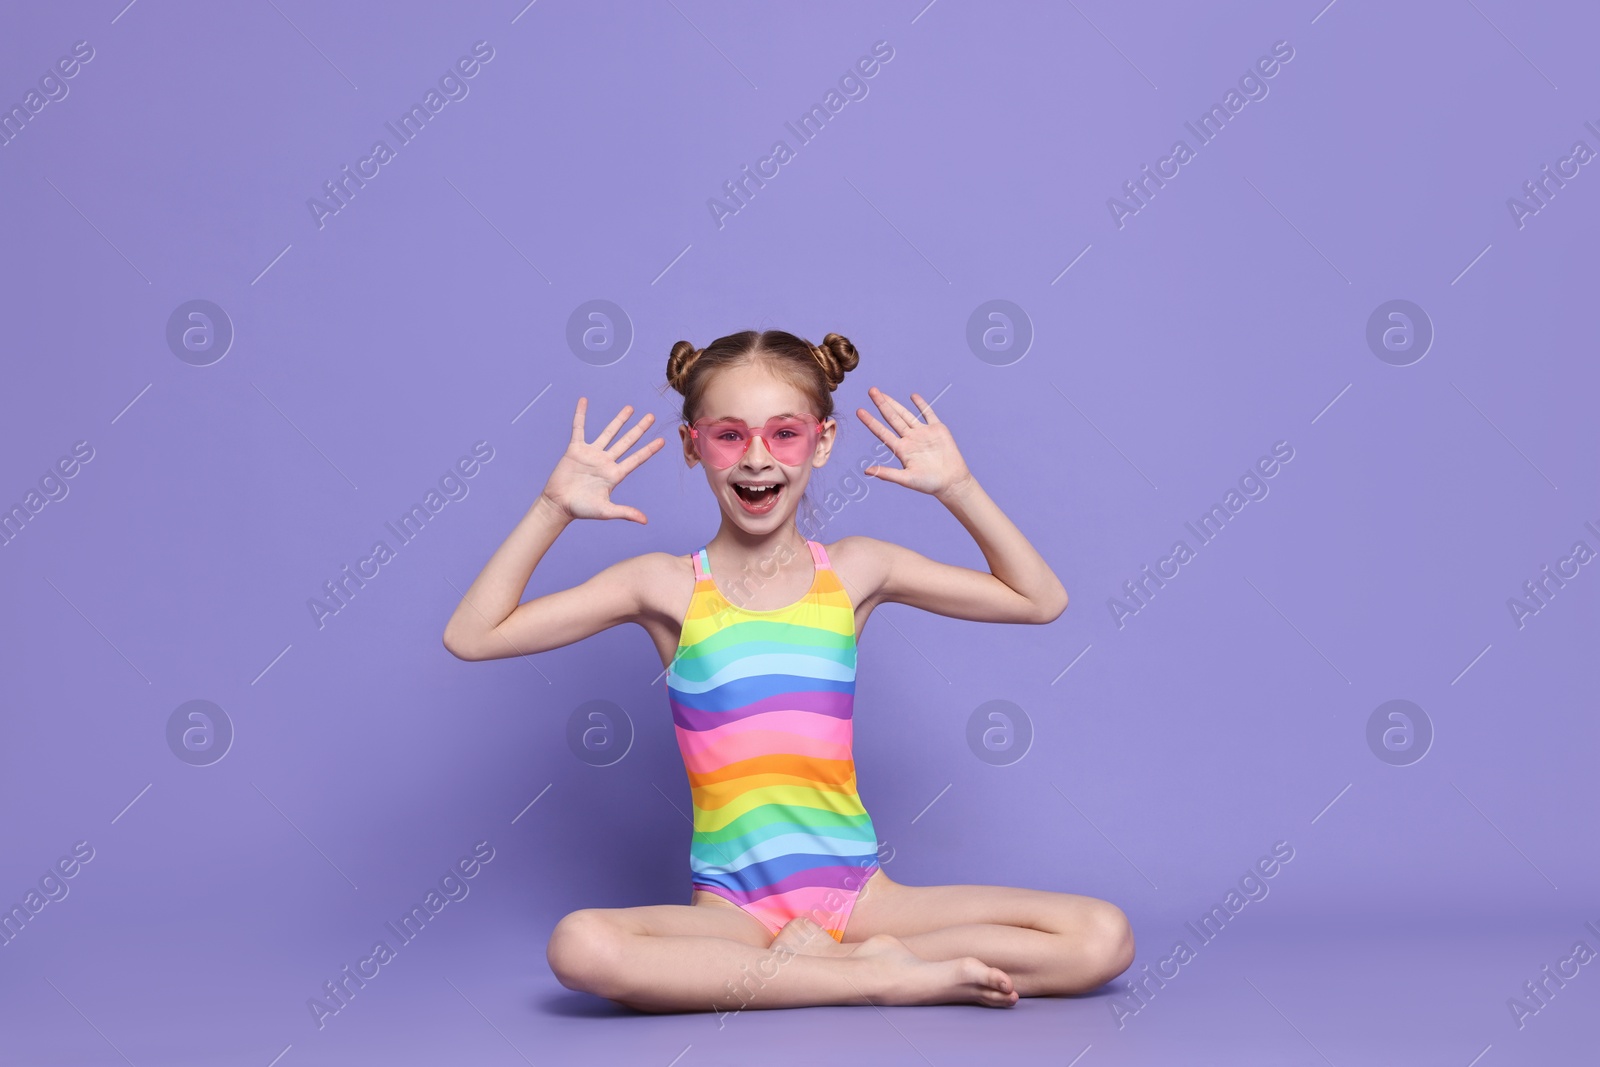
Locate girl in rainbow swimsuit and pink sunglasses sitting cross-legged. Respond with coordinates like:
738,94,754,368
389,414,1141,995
443,330,1133,1013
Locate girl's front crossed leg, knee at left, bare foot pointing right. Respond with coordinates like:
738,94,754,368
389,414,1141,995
546,893,1016,1013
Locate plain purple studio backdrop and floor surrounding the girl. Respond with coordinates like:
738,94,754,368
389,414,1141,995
0,0,1600,1067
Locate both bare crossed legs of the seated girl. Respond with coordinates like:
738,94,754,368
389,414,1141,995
546,869,1133,1013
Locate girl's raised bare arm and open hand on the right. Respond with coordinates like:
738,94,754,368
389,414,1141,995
858,389,1067,622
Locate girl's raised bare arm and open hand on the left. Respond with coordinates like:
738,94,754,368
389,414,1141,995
443,397,664,659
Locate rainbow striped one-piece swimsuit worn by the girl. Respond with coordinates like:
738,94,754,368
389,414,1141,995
667,541,878,941
